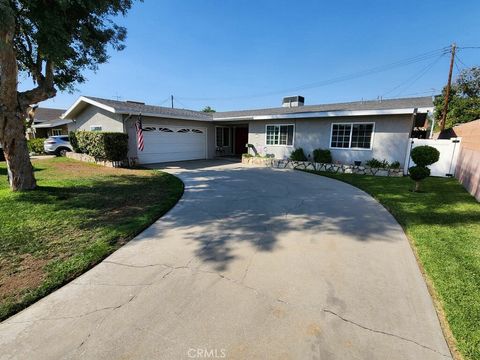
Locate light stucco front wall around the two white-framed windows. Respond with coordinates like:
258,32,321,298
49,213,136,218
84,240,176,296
248,115,412,166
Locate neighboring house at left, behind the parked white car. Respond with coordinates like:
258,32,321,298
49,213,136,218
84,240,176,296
27,107,72,138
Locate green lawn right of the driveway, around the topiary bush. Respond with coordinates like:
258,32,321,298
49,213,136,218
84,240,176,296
306,172,480,359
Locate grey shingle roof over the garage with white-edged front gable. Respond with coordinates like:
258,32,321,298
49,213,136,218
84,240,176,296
63,96,212,121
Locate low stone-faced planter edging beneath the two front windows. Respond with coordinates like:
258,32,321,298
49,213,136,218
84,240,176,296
242,157,403,176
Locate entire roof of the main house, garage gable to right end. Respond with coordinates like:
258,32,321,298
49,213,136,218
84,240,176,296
62,96,433,121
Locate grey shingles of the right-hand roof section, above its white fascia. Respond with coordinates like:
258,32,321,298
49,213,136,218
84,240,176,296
213,96,433,120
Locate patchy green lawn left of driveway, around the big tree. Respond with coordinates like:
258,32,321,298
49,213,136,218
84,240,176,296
0,158,183,320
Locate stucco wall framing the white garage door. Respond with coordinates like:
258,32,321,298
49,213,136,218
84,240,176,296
124,115,215,159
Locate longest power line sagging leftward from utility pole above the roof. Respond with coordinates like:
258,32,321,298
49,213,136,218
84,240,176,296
176,47,450,101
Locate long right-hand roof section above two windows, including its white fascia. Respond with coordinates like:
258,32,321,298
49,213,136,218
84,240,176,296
213,96,433,120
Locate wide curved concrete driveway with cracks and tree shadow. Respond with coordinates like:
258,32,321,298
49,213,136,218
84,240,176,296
0,162,450,360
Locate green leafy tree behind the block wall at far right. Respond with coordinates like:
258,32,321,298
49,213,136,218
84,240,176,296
434,67,480,129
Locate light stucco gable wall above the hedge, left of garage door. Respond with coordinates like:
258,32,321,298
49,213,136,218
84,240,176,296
68,105,123,132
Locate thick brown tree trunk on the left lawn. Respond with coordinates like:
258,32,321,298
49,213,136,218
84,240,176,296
0,7,36,191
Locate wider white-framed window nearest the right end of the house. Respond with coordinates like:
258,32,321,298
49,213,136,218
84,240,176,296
330,123,374,149
